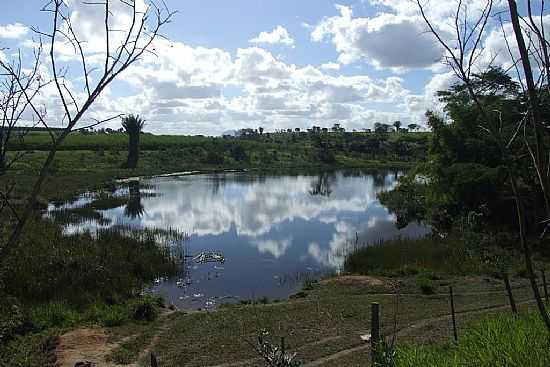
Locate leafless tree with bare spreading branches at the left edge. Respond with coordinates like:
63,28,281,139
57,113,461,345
0,0,174,261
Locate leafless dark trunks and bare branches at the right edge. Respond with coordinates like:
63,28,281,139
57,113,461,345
416,0,550,332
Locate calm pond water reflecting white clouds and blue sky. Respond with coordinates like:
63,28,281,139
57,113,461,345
49,171,429,308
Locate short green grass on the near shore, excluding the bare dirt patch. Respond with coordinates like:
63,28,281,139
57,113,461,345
140,278,540,366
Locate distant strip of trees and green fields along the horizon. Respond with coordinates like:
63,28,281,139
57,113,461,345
11,131,430,164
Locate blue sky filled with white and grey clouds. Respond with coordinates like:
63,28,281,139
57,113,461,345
0,0,550,135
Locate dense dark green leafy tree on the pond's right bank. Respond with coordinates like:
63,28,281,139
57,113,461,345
381,68,540,230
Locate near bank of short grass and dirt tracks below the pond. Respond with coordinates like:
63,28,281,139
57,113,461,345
101,276,540,366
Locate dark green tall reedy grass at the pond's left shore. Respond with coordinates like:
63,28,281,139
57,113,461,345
4,218,177,305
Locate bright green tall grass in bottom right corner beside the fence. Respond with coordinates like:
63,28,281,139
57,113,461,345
397,312,550,367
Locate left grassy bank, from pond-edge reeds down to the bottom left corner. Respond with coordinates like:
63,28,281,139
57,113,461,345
0,217,183,367
